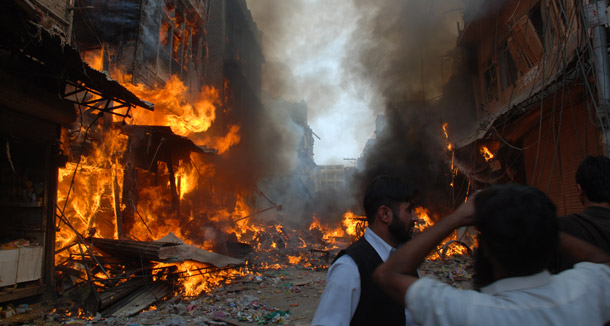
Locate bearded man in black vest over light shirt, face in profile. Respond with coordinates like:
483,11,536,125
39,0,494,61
312,176,417,326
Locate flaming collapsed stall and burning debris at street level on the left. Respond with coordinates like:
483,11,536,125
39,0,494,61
55,116,364,316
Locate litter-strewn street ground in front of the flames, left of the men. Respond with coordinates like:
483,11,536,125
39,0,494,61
35,266,326,326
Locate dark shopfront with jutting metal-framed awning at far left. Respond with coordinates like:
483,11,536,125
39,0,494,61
0,0,151,302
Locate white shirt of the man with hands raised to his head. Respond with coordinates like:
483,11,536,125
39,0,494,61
405,263,610,326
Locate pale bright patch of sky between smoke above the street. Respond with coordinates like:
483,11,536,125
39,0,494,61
247,0,376,164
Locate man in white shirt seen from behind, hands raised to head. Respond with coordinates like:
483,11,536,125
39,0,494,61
374,184,610,326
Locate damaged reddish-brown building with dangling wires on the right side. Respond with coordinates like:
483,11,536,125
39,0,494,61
454,0,610,214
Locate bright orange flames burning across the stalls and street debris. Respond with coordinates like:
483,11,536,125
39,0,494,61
56,51,472,310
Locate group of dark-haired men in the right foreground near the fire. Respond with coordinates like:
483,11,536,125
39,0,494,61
312,156,610,326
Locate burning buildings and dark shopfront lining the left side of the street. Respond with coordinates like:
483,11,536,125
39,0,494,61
0,0,290,314
